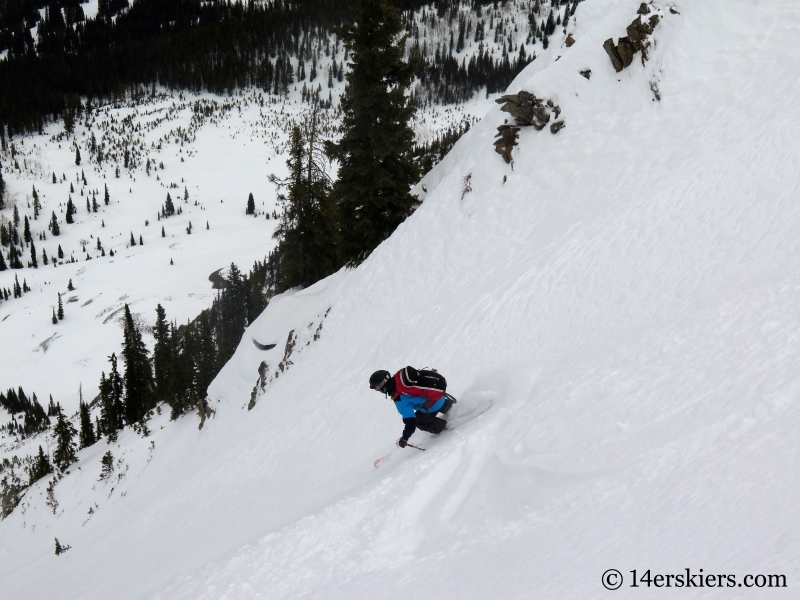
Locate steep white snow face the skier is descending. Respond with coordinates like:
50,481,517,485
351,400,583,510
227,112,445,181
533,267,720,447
0,0,800,599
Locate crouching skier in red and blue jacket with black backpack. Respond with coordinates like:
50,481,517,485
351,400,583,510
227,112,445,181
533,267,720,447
369,367,456,448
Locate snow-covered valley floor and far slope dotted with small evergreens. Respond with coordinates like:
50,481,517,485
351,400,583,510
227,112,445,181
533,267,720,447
0,2,540,515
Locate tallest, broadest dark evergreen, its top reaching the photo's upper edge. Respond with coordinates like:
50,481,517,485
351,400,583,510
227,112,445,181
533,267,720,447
326,0,419,266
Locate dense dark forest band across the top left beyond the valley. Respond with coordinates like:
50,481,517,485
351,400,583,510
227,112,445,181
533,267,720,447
0,0,450,134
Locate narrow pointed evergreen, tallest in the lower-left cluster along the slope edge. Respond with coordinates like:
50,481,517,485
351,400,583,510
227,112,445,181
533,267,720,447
122,304,155,424
